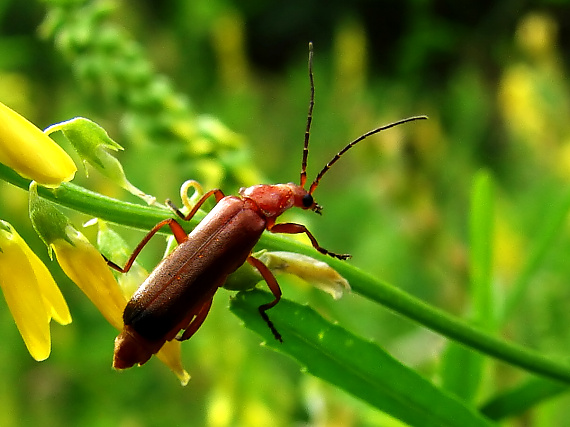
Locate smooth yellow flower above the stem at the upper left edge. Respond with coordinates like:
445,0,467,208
0,103,77,187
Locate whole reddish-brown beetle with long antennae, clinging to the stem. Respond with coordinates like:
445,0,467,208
107,43,427,369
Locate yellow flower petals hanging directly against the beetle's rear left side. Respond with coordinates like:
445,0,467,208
51,227,127,330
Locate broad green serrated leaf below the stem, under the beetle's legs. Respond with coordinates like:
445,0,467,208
230,290,493,427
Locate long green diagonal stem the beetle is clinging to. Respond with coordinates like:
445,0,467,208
4,165,570,383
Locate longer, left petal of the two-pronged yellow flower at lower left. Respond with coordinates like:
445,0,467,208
0,224,51,361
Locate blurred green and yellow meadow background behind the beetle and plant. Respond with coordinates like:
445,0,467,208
0,0,570,427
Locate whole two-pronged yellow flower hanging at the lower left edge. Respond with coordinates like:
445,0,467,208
0,220,71,360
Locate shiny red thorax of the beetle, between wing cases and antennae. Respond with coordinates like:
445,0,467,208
239,183,307,218
